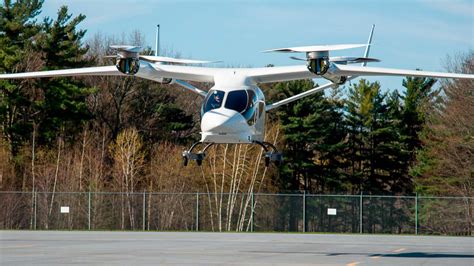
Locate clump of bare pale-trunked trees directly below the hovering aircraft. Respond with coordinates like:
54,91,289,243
202,121,280,231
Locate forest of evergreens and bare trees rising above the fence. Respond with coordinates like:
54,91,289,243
0,0,474,233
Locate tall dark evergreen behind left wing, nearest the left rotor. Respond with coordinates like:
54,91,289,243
35,6,92,143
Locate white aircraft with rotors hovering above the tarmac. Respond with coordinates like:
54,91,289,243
0,26,474,166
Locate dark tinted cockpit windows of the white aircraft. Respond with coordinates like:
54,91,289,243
201,90,257,121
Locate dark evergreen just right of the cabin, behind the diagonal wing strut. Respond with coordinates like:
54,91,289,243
274,80,345,193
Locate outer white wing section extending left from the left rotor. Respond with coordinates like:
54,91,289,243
0,66,123,79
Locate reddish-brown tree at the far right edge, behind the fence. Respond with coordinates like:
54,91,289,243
410,51,474,236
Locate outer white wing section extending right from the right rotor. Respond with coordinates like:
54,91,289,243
335,65,474,79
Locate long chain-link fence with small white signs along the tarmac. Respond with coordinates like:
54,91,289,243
0,192,474,236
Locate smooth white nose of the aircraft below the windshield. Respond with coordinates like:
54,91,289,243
201,109,247,133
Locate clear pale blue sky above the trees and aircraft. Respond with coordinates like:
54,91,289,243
41,0,474,89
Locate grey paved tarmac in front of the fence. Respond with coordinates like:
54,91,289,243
0,231,474,266
